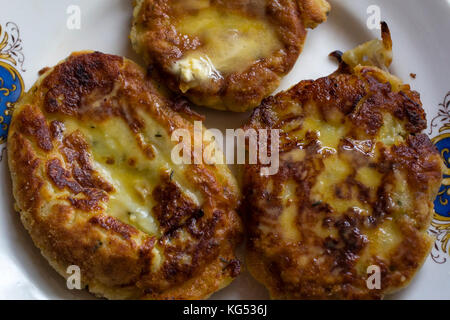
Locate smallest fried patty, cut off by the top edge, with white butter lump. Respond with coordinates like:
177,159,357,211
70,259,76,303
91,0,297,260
131,0,330,112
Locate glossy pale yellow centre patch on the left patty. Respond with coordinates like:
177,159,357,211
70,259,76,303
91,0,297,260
54,112,203,237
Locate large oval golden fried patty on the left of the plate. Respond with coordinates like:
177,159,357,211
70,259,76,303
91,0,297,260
8,52,241,299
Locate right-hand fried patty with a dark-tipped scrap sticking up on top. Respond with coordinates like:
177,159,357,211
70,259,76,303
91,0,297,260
243,25,442,299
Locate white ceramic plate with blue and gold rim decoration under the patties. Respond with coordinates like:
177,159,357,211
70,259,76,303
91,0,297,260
0,0,450,299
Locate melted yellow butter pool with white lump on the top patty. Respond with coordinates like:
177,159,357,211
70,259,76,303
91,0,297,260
173,5,281,82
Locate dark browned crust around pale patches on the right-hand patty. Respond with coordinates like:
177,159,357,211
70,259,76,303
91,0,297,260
243,63,442,299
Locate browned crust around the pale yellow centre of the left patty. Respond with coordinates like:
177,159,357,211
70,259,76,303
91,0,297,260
8,52,241,299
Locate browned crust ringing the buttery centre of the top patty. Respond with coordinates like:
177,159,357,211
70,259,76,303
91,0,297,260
131,0,330,112
